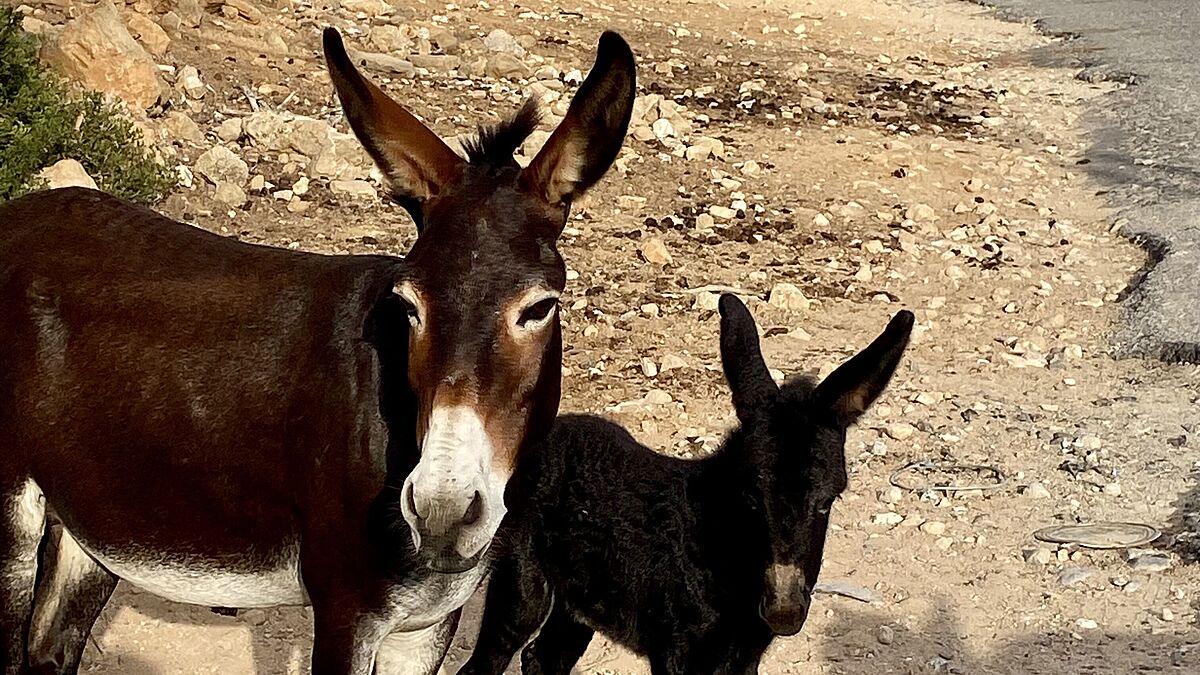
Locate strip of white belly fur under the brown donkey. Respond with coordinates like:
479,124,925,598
88,549,308,609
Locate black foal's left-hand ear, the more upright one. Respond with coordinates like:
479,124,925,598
716,293,779,422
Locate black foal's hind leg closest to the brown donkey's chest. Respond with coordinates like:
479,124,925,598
458,556,552,675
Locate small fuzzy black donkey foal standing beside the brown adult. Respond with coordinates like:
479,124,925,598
460,295,913,675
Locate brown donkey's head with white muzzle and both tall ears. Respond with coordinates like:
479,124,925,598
325,29,636,572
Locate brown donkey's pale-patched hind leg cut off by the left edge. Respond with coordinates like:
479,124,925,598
0,479,46,675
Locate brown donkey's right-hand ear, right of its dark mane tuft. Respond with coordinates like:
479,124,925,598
521,31,637,207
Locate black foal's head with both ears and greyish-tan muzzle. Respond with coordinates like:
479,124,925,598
720,295,913,635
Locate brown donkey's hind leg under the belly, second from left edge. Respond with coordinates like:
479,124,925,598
29,521,118,675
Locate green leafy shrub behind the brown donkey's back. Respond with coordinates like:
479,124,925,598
0,7,175,203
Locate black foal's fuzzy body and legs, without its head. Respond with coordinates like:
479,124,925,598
475,416,774,675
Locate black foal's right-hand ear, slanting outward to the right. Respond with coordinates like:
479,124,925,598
814,310,913,428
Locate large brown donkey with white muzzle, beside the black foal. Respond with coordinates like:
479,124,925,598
0,30,635,675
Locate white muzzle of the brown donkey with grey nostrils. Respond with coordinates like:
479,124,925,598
401,406,509,565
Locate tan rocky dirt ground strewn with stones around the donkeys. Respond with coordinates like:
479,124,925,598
4,0,1200,675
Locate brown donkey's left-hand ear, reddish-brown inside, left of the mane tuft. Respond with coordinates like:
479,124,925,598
324,28,464,222
